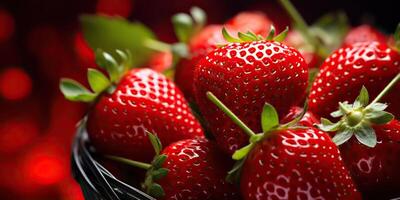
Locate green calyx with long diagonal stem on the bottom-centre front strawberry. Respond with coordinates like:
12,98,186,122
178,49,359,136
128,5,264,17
206,92,307,183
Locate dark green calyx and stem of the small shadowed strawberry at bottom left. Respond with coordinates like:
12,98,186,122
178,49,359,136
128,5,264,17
106,131,169,198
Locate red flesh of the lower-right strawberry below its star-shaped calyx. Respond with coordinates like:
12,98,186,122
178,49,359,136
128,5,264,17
340,120,400,199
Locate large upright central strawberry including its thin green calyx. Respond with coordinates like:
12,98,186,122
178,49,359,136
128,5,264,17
194,30,307,154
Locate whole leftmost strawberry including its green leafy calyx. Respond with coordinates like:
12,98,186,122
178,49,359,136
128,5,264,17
60,51,202,160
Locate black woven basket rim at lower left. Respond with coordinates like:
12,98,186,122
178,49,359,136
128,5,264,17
71,128,155,200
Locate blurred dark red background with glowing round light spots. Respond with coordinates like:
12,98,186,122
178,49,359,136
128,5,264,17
0,0,400,200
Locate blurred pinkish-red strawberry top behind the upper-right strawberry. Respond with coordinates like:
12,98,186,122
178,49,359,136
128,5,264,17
343,24,387,45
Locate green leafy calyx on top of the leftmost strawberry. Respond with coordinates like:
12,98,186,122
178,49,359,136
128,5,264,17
59,50,132,102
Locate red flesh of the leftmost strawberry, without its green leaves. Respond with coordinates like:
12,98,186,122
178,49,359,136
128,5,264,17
87,69,202,161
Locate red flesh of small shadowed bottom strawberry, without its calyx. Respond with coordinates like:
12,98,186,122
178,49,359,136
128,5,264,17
158,138,239,199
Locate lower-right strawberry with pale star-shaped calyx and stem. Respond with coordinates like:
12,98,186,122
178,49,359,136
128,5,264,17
319,73,400,199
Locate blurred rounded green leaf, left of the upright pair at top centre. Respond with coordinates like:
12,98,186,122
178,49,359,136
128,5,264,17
172,13,194,43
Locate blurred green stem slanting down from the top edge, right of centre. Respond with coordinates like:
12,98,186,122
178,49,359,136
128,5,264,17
279,0,328,58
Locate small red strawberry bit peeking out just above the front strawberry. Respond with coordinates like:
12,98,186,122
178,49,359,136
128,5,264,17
281,106,319,127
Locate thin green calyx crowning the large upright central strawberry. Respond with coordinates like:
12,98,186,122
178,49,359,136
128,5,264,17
222,25,289,43
